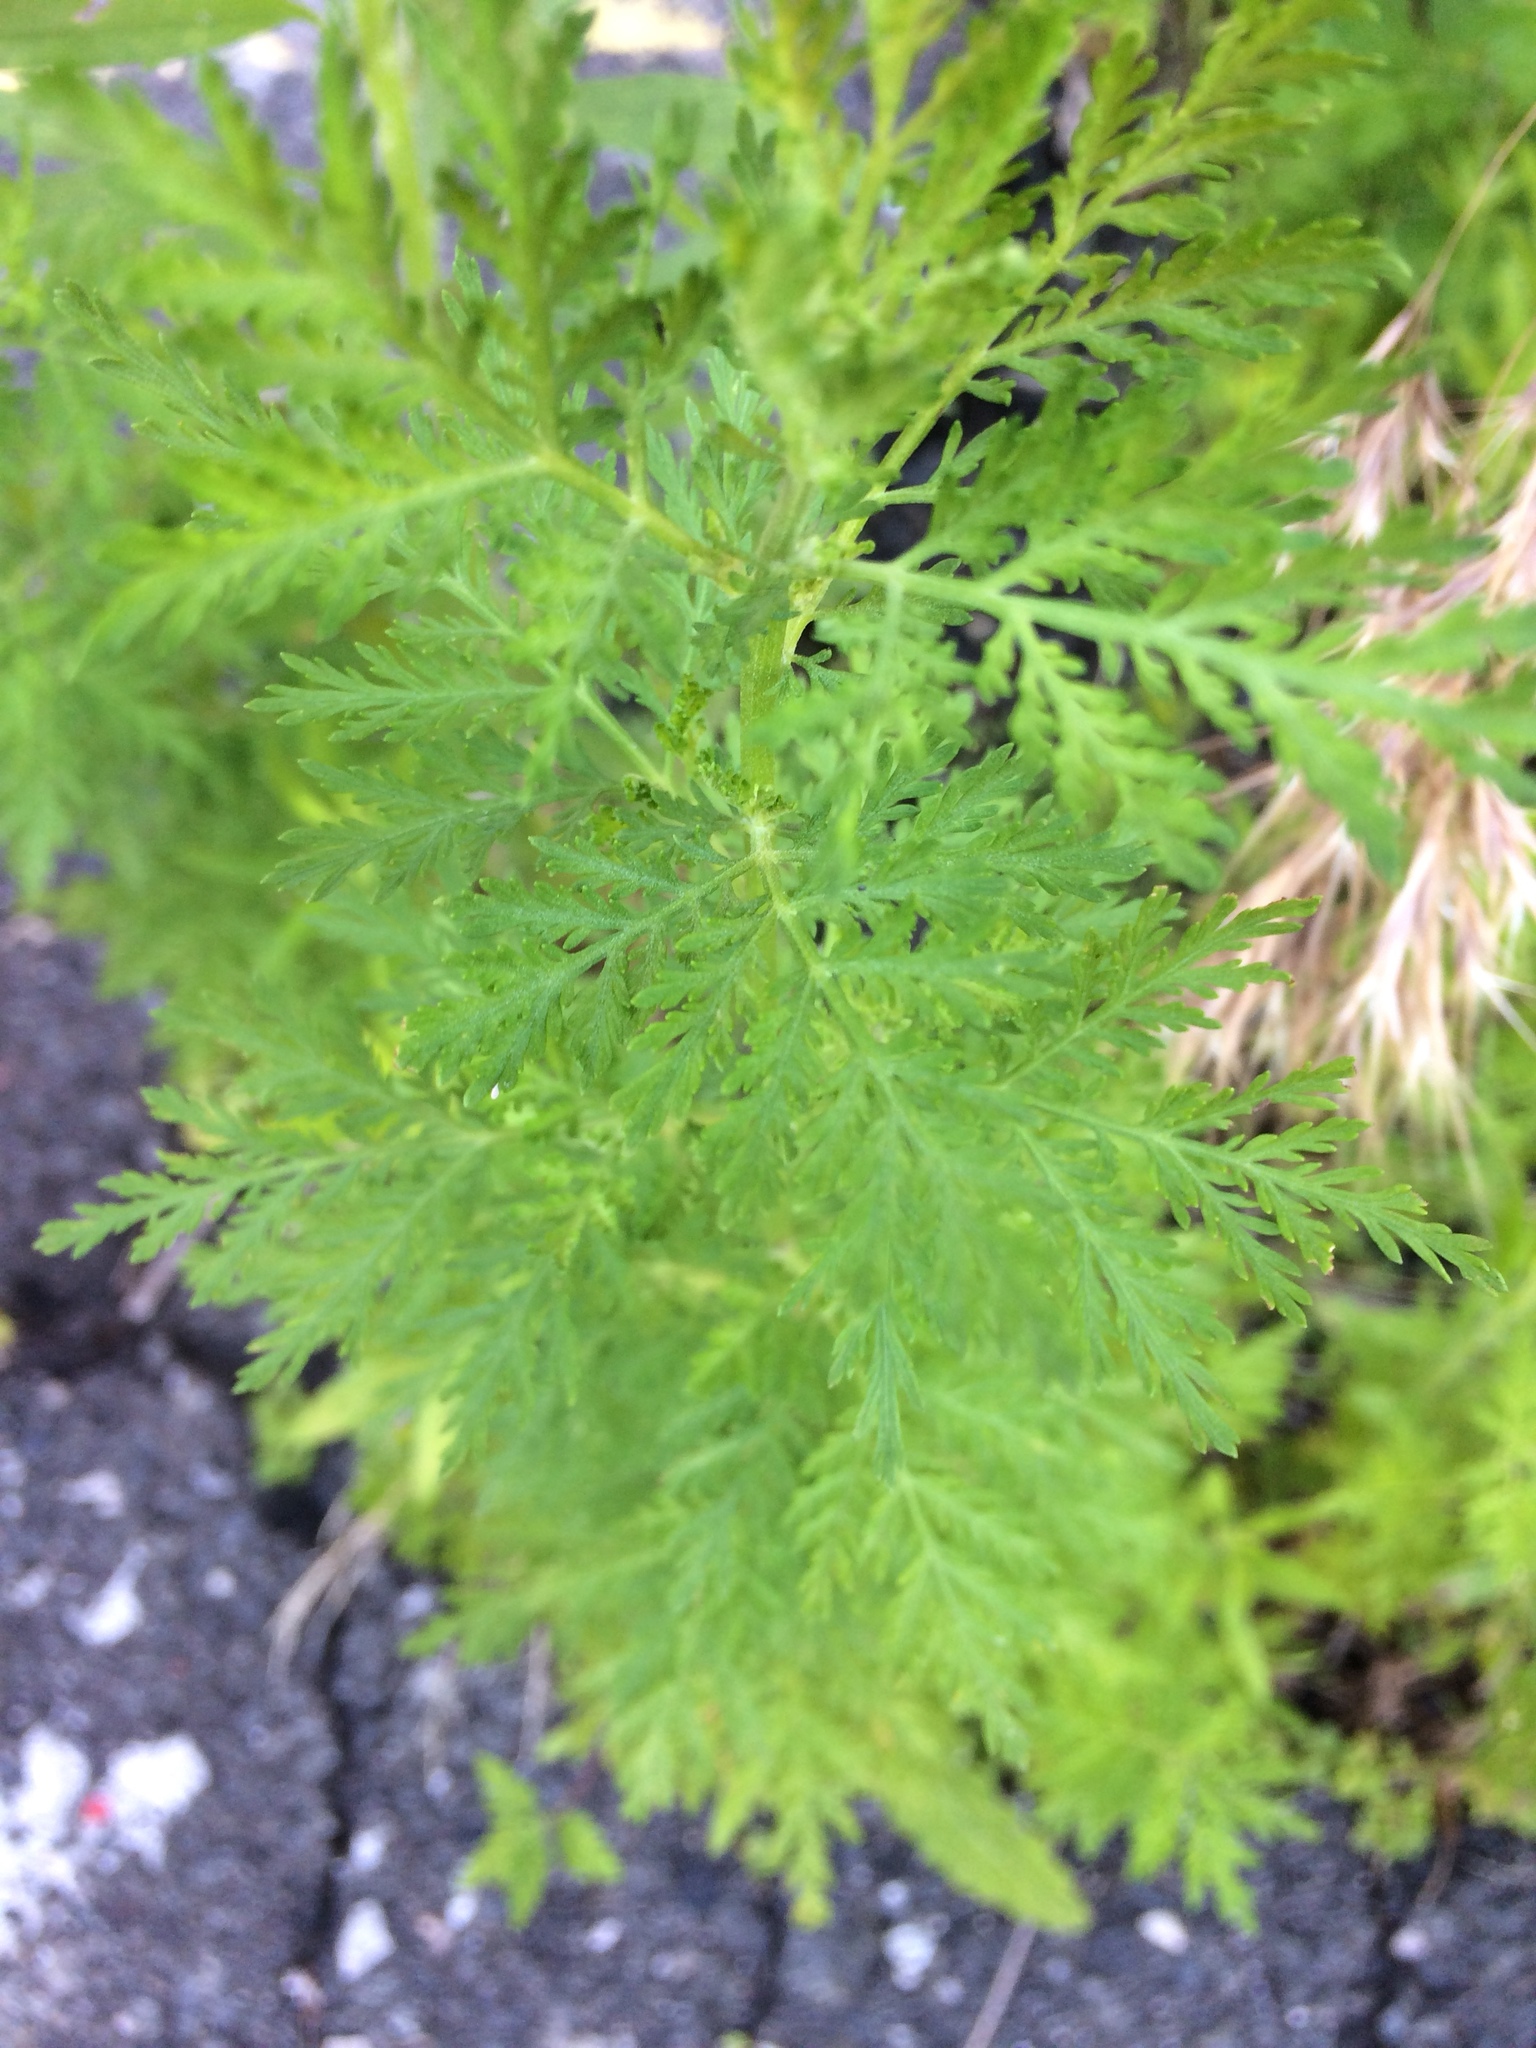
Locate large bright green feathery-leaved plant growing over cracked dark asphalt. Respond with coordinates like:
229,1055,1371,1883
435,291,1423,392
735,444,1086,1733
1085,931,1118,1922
4,0,1532,1925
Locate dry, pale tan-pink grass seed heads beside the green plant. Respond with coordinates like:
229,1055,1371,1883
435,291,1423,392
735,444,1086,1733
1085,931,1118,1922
1184,106,1536,1143
